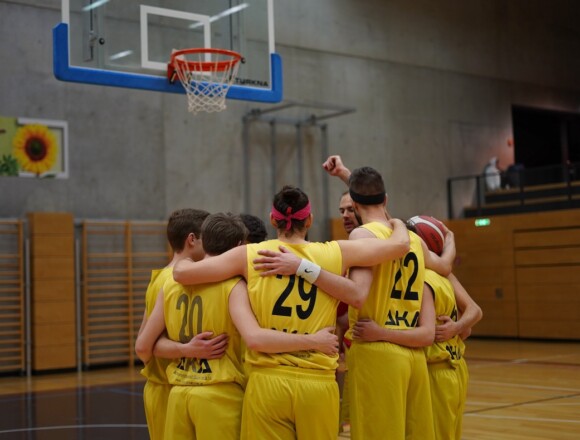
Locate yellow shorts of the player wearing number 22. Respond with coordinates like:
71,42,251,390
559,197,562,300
347,342,434,440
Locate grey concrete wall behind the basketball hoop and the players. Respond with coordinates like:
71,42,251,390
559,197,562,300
0,0,580,238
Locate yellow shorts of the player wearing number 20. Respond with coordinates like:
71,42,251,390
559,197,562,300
165,382,244,440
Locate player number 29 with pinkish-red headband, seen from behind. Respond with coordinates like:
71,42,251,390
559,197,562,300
173,186,409,440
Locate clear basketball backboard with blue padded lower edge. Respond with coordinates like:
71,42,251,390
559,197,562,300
53,0,282,102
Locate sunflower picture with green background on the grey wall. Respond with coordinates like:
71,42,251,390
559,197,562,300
0,117,68,177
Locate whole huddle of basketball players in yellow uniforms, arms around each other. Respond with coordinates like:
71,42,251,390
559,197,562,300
135,156,481,440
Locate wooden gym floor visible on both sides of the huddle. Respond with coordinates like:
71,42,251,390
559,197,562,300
0,339,580,440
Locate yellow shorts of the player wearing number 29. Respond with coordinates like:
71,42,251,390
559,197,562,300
241,366,339,440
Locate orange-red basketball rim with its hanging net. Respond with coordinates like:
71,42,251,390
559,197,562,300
167,49,243,115
